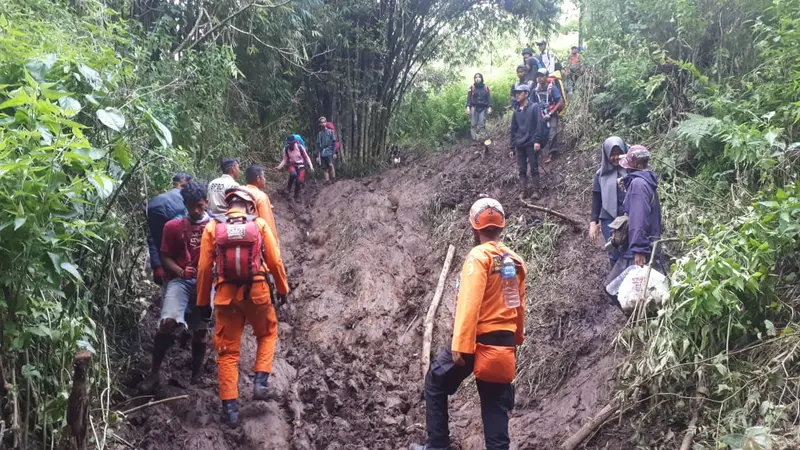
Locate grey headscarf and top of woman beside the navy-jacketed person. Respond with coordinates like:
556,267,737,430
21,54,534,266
592,136,628,222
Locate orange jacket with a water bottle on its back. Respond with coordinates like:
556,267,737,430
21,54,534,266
452,242,527,353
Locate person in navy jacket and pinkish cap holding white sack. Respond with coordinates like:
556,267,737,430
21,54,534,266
605,145,668,302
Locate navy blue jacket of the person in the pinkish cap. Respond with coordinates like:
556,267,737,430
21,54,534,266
622,170,661,258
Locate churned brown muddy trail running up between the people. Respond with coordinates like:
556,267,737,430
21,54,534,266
115,140,624,450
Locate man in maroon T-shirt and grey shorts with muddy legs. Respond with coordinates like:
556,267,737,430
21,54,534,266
139,181,209,394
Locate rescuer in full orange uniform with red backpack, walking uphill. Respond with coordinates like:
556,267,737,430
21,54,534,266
197,187,289,427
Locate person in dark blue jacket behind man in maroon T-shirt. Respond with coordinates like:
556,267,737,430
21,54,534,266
145,172,192,292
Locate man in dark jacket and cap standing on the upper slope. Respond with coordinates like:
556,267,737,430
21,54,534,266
510,84,547,198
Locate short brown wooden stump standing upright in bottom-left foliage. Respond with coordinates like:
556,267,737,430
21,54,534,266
63,350,92,450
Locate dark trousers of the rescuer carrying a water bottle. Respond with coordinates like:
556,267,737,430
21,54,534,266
425,349,514,450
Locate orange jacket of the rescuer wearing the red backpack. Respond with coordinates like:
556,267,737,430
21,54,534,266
197,212,289,306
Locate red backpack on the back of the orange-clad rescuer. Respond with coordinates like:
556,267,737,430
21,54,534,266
215,216,267,286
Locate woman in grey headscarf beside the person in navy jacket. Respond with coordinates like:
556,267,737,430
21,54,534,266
589,136,628,265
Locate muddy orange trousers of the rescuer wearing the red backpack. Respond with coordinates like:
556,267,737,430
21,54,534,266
214,298,278,400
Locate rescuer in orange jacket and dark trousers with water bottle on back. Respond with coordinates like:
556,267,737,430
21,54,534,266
411,198,525,450
